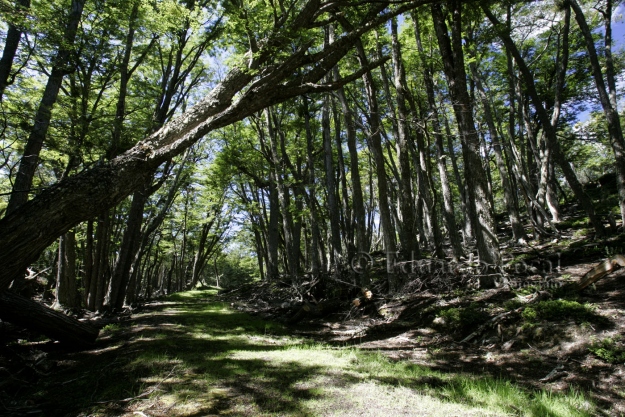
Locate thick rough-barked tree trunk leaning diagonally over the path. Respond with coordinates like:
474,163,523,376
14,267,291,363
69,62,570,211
0,0,414,344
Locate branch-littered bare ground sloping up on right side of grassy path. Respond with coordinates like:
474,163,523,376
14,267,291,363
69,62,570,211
208,211,625,416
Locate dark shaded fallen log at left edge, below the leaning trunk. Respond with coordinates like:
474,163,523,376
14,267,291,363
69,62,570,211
0,291,100,347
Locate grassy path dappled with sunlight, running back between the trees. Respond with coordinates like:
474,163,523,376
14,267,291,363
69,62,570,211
29,291,596,417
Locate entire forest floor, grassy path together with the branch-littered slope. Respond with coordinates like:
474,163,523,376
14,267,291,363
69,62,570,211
0,213,625,417
